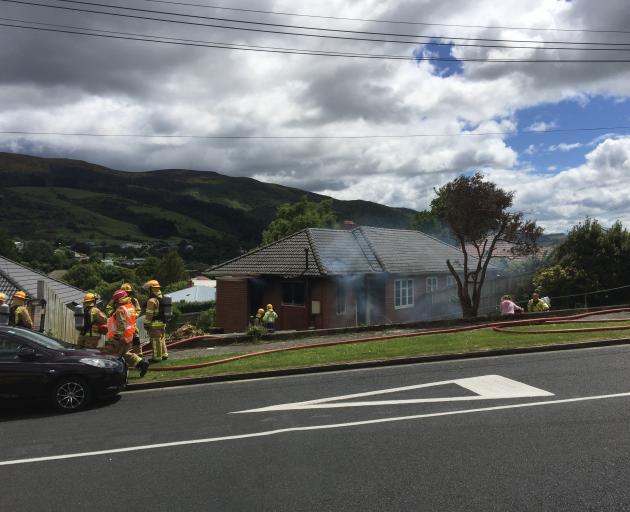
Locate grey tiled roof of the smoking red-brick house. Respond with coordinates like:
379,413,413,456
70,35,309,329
208,227,482,276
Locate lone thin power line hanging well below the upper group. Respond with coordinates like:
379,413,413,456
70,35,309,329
0,126,630,140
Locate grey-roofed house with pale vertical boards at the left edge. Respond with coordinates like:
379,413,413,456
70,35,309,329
0,256,85,342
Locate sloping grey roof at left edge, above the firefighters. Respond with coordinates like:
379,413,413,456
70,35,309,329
0,256,85,304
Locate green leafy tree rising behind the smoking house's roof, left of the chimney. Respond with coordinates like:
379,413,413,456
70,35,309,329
262,196,337,244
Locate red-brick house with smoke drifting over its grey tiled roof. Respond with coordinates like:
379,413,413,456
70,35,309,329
207,226,492,332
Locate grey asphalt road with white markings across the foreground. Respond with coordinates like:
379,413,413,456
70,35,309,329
0,347,630,512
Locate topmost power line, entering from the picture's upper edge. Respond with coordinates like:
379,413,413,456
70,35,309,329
138,0,630,34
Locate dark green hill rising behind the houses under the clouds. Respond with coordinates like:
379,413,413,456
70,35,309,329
0,153,415,263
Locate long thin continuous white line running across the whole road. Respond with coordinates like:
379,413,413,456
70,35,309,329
0,392,630,466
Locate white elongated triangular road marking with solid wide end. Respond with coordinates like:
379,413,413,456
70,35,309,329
232,375,553,414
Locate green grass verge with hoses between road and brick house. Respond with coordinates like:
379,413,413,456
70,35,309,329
130,322,630,382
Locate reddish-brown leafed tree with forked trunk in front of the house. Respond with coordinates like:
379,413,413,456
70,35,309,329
431,172,543,318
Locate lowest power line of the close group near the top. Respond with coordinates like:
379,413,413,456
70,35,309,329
8,21,630,64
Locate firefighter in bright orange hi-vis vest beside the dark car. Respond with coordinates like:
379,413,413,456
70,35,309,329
104,290,149,377
